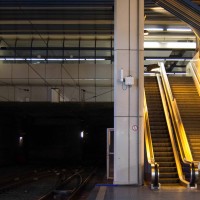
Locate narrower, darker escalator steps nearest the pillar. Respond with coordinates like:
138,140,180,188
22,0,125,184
144,77,179,185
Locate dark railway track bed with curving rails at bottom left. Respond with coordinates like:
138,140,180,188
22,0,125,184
0,168,96,200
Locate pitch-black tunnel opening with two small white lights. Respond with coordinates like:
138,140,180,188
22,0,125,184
0,102,114,169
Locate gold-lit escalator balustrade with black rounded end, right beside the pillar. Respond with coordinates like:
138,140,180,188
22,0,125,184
144,92,160,189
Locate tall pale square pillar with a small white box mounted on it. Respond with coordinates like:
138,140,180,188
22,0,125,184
114,0,144,185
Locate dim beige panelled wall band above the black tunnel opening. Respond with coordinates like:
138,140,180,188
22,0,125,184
0,64,113,102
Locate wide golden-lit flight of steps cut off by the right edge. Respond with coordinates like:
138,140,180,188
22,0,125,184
168,77,200,161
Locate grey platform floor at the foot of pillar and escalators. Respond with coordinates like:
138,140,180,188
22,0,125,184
88,185,200,200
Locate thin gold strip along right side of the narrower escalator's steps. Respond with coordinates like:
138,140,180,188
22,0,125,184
156,74,190,187
